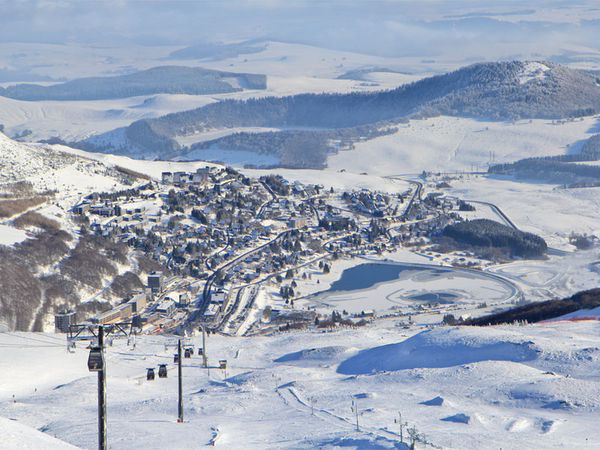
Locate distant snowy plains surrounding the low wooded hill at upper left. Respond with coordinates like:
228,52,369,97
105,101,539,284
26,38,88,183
0,42,432,145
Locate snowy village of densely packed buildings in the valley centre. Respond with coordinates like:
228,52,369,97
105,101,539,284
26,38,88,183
61,162,472,329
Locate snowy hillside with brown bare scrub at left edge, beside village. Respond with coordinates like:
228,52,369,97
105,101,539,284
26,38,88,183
0,133,161,331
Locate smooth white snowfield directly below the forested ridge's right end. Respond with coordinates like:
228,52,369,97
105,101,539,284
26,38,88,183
327,116,600,176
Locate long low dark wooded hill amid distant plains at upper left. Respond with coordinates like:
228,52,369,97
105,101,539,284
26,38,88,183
0,66,267,101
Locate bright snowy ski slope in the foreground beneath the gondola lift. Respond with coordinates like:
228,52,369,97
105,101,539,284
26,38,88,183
0,312,600,449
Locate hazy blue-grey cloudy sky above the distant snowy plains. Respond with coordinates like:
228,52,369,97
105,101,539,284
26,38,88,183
0,0,600,59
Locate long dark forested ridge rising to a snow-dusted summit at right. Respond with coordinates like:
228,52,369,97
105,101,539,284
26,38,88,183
81,61,600,168
